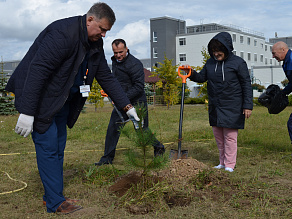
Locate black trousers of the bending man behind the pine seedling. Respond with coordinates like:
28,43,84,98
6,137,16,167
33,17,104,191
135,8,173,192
99,105,164,163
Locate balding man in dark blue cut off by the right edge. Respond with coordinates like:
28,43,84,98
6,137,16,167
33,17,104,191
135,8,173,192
272,41,292,143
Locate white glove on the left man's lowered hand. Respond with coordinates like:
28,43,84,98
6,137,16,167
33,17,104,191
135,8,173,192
15,113,34,138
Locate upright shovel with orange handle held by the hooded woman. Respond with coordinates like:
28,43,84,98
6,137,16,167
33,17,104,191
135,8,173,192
169,65,192,160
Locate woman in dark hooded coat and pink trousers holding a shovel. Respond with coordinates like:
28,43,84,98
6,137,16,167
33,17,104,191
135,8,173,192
189,32,253,172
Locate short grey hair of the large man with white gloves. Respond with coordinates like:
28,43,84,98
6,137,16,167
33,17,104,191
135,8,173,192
87,2,116,25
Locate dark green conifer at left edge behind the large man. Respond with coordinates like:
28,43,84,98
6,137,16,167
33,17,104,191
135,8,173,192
0,60,17,115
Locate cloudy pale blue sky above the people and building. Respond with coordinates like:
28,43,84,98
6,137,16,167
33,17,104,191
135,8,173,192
0,0,292,61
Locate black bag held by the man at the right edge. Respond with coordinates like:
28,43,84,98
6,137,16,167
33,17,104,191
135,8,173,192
258,84,289,114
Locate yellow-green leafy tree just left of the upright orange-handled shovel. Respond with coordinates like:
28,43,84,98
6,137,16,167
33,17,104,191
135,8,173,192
152,56,181,108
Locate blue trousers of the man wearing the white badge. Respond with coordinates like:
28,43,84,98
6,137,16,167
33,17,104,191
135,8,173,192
32,104,69,212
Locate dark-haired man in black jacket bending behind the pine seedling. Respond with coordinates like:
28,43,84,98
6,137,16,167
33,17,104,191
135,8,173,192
95,39,165,166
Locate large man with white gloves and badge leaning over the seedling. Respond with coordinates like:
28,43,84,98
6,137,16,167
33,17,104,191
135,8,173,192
6,2,139,214
